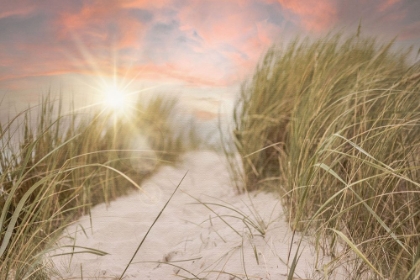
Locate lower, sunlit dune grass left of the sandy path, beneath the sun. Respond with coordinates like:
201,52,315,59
0,93,199,279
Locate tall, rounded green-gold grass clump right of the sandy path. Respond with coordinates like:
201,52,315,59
234,32,420,279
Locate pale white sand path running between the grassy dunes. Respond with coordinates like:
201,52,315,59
50,152,339,279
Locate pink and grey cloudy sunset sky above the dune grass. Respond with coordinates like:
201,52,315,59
0,0,420,118
